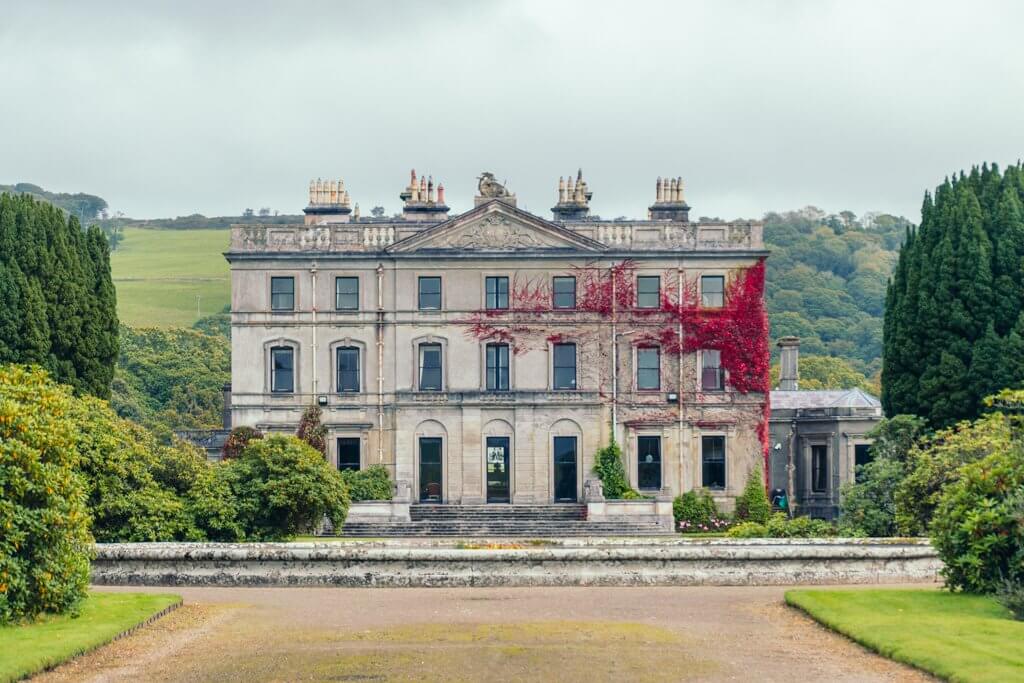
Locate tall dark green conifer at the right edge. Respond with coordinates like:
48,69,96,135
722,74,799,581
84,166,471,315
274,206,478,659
882,164,1024,427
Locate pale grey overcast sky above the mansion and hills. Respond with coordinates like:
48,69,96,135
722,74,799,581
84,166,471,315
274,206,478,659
0,0,1024,221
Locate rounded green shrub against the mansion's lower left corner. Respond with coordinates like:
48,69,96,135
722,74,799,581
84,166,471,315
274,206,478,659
228,435,348,541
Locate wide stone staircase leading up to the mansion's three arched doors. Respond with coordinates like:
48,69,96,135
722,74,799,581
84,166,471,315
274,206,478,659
342,504,672,538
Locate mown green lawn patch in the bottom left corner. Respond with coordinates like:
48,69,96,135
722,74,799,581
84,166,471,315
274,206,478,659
0,593,181,681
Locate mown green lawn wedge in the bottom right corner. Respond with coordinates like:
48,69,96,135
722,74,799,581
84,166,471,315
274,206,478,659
785,590,1024,682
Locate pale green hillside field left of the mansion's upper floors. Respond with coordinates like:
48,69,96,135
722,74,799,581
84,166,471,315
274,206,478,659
111,227,231,328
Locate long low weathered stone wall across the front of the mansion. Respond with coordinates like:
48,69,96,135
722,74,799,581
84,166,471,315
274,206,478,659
92,539,941,587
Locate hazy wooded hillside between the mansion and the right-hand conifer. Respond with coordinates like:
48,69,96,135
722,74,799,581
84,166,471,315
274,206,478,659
764,207,910,388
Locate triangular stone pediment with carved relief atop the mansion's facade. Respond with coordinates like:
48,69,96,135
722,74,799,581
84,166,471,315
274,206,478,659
387,201,606,254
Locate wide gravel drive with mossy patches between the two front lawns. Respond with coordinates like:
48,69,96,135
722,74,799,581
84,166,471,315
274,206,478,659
39,585,934,683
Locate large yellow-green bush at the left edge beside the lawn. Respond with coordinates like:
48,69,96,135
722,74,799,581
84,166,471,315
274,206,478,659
0,366,92,624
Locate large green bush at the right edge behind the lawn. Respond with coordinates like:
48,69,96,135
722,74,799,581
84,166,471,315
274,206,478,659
932,443,1024,593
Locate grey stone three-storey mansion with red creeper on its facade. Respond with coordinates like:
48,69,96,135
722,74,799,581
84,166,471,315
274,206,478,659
225,171,768,508
